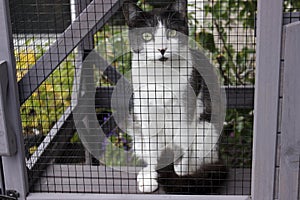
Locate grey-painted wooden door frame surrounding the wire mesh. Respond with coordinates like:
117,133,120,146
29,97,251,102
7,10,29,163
0,0,296,200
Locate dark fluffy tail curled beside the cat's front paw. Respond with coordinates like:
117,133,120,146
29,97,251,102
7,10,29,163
158,160,228,195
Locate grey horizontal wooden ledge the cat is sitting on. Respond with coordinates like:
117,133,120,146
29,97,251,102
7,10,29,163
33,165,251,195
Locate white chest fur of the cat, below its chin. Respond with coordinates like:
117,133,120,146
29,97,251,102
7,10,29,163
131,57,192,136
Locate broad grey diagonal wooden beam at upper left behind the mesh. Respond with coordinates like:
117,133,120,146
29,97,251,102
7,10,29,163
18,0,123,103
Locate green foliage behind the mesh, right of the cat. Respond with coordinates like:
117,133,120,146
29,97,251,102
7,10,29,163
192,0,256,167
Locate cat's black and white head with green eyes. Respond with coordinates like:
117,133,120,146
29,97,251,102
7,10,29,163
123,0,188,62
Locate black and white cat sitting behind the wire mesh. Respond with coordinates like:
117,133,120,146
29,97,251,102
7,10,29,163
123,0,224,193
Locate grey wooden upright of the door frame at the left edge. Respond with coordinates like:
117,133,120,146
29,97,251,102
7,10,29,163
0,0,28,200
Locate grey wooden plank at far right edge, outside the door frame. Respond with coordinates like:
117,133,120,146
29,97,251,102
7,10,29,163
279,22,300,200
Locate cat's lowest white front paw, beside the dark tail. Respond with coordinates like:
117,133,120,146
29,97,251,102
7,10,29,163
137,171,158,193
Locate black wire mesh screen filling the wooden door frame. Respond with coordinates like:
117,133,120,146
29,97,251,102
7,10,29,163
9,0,256,198
